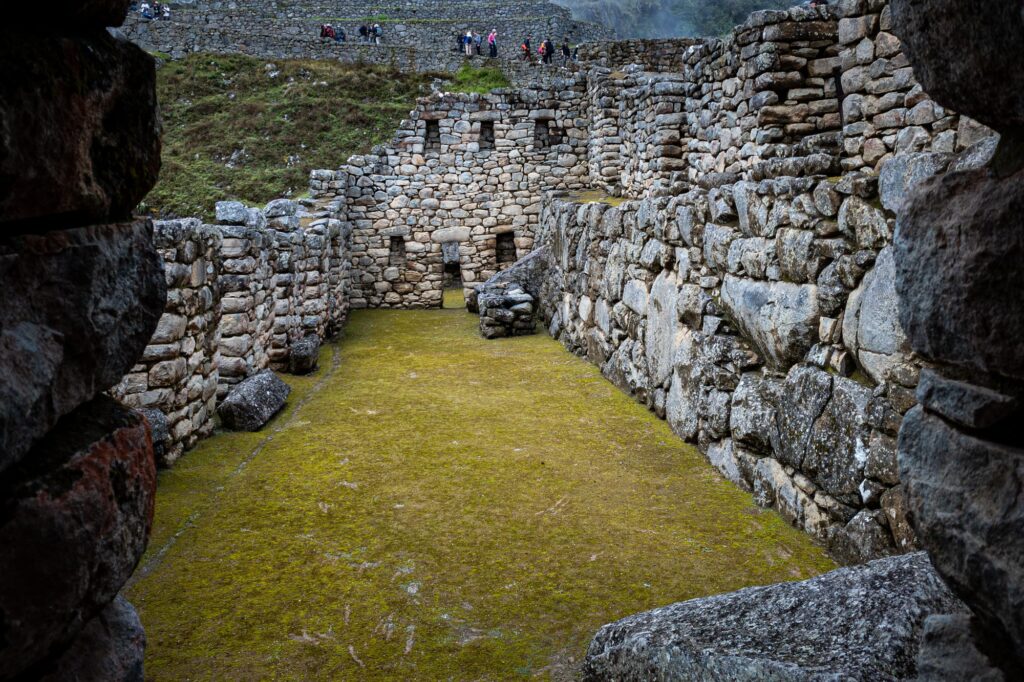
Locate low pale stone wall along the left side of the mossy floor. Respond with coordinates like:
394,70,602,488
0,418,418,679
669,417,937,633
112,200,350,466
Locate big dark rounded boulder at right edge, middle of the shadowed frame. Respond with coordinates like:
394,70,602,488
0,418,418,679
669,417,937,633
894,162,1024,380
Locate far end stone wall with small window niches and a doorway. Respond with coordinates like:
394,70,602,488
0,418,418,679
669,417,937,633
312,79,589,307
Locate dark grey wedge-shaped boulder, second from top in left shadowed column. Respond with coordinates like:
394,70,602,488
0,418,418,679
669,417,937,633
0,221,167,471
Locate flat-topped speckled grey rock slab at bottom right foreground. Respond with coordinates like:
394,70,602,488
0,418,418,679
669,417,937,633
584,552,965,682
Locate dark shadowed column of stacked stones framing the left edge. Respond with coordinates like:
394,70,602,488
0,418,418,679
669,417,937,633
0,0,166,682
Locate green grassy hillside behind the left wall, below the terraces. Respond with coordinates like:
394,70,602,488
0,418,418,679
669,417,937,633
143,54,503,218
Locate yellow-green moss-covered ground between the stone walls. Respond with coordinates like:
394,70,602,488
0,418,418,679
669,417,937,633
128,308,831,680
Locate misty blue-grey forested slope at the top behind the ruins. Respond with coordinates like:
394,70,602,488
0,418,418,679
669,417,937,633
554,0,802,38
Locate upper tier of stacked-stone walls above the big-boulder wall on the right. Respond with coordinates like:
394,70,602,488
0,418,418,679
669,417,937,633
581,0,989,198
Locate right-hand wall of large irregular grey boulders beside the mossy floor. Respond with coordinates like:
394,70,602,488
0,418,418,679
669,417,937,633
539,169,942,562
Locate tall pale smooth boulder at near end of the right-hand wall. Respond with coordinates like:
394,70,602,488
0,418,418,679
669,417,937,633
843,247,910,383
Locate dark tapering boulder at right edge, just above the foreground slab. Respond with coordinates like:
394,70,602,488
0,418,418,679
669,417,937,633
899,406,1024,662
